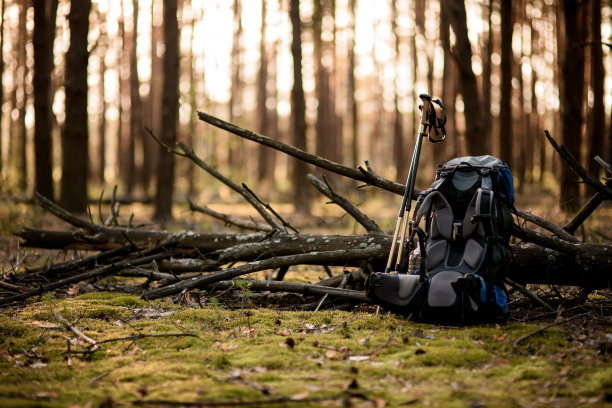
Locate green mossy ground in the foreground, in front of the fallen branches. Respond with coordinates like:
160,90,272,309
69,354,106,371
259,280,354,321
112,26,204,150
0,292,612,407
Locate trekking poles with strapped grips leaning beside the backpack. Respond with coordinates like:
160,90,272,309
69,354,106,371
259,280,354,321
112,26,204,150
385,94,446,273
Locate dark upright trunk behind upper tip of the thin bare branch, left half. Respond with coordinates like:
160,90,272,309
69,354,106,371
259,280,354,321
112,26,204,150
153,0,179,221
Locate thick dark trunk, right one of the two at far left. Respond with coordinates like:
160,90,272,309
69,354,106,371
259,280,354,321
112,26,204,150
60,0,91,213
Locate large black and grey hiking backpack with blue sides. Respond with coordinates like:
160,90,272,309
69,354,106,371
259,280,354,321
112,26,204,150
366,155,514,324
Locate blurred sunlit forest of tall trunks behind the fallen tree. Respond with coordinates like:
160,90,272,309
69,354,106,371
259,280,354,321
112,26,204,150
0,0,612,220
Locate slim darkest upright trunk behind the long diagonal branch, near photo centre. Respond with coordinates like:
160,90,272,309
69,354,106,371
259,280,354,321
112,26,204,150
289,0,310,213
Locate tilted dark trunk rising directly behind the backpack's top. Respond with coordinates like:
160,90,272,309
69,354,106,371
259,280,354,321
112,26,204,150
443,0,489,156
